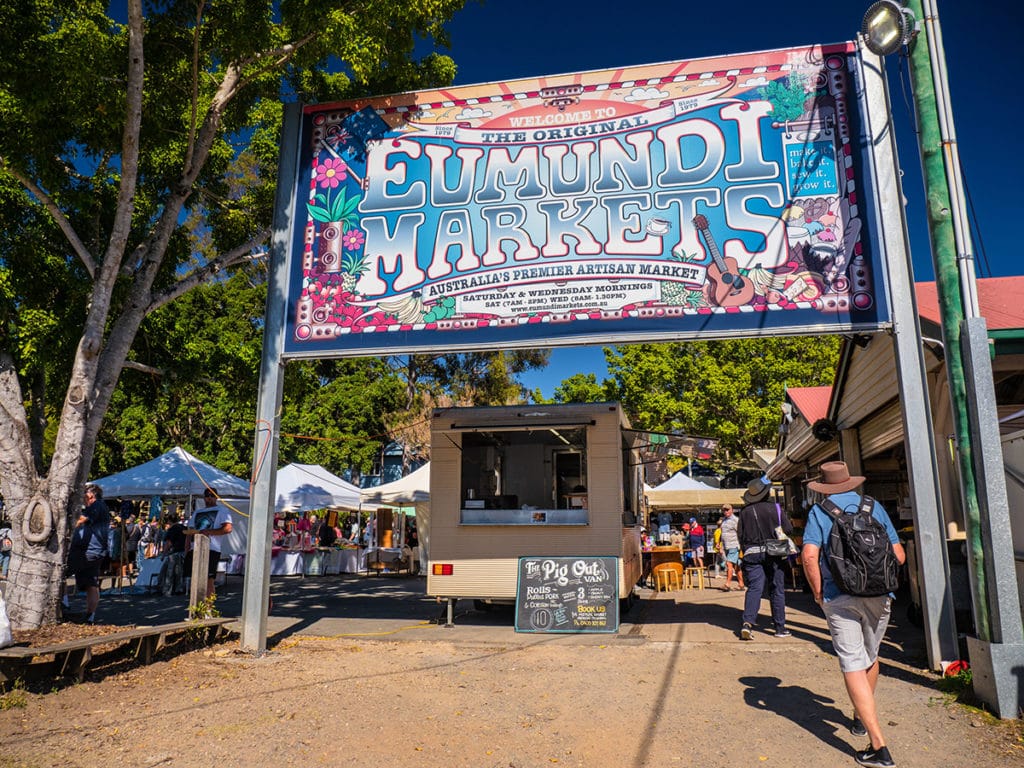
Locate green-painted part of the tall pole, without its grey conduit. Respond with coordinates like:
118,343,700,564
906,0,991,641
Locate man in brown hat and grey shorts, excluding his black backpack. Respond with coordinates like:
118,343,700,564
801,462,906,768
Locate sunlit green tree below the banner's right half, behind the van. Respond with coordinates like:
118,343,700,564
605,336,840,457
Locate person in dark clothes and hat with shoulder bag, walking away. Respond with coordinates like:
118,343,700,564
736,476,793,640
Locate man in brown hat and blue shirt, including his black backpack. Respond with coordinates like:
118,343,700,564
801,462,906,768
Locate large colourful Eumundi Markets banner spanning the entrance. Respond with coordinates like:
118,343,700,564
285,44,888,356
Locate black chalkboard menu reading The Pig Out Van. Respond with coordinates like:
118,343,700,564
515,557,618,632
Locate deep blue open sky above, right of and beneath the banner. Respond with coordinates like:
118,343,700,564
438,0,1024,395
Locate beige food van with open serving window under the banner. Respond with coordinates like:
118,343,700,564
427,402,643,624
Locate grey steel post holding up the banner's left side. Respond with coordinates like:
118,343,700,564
240,103,302,653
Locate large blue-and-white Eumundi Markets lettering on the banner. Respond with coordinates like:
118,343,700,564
358,101,785,299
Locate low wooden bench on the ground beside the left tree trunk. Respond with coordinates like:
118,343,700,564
0,616,236,684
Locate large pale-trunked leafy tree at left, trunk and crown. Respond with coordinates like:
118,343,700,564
0,0,463,628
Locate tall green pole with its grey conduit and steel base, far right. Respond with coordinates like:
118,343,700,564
907,0,1024,718
